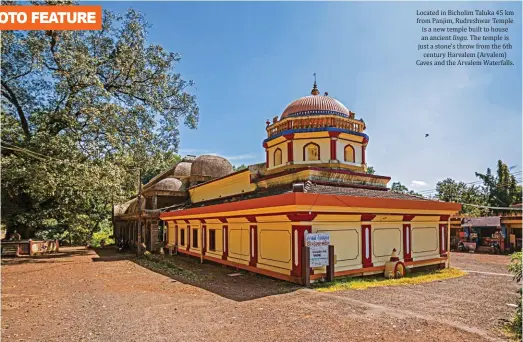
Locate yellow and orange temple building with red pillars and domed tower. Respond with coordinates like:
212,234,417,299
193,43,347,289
115,82,461,283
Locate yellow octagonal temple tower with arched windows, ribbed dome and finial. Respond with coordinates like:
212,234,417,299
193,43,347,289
263,80,369,173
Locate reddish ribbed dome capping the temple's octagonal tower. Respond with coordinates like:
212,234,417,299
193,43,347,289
280,95,351,120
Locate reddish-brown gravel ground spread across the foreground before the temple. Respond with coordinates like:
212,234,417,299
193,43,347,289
2,248,517,341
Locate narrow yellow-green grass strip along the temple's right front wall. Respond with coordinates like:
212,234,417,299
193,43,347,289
313,268,466,292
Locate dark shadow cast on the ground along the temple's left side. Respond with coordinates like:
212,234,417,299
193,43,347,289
93,249,301,302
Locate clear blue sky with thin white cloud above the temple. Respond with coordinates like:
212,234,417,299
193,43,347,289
102,1,522,190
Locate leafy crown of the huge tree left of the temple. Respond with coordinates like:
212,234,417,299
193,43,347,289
1,1,198,241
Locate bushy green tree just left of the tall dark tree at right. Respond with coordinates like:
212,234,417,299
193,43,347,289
436,178,487,216
